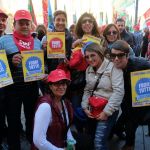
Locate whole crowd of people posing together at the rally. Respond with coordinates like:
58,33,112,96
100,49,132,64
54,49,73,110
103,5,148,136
0,7,150,150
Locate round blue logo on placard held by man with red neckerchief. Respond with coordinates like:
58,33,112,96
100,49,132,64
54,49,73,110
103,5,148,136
26,56,42,75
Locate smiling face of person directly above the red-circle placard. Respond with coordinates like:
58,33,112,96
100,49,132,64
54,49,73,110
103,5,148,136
54,14,67,32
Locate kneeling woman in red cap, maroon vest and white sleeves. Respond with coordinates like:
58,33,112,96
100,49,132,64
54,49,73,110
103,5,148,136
33,69,76,150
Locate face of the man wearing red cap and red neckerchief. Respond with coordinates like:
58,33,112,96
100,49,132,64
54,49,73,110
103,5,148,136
14,19,32,36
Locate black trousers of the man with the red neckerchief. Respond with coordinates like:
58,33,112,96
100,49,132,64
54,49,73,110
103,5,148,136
5,82,38,150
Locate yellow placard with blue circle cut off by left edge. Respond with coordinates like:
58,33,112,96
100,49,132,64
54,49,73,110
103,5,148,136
0,50,13,88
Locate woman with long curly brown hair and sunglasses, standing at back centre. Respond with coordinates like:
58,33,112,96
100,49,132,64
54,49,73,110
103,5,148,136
69,12,105,132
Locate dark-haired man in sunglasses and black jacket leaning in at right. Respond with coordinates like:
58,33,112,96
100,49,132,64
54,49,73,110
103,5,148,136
110,40,150,150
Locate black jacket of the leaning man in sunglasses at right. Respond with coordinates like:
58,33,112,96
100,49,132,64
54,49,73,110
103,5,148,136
121,57,150,115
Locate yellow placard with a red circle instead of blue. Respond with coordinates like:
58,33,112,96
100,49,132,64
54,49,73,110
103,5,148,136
47,32,66,58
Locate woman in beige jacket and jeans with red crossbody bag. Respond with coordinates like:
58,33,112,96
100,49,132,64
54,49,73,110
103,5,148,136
81,43,124,150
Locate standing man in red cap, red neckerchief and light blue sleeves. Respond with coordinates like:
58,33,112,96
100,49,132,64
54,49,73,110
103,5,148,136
0,10,41,150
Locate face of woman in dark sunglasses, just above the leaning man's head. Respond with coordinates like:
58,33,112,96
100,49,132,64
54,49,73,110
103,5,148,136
106,26,119,43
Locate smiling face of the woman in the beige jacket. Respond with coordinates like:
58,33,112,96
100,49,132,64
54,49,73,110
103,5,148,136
85,51,103,69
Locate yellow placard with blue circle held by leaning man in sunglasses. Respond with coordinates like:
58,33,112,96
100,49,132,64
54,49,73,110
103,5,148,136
131,69,150,107
